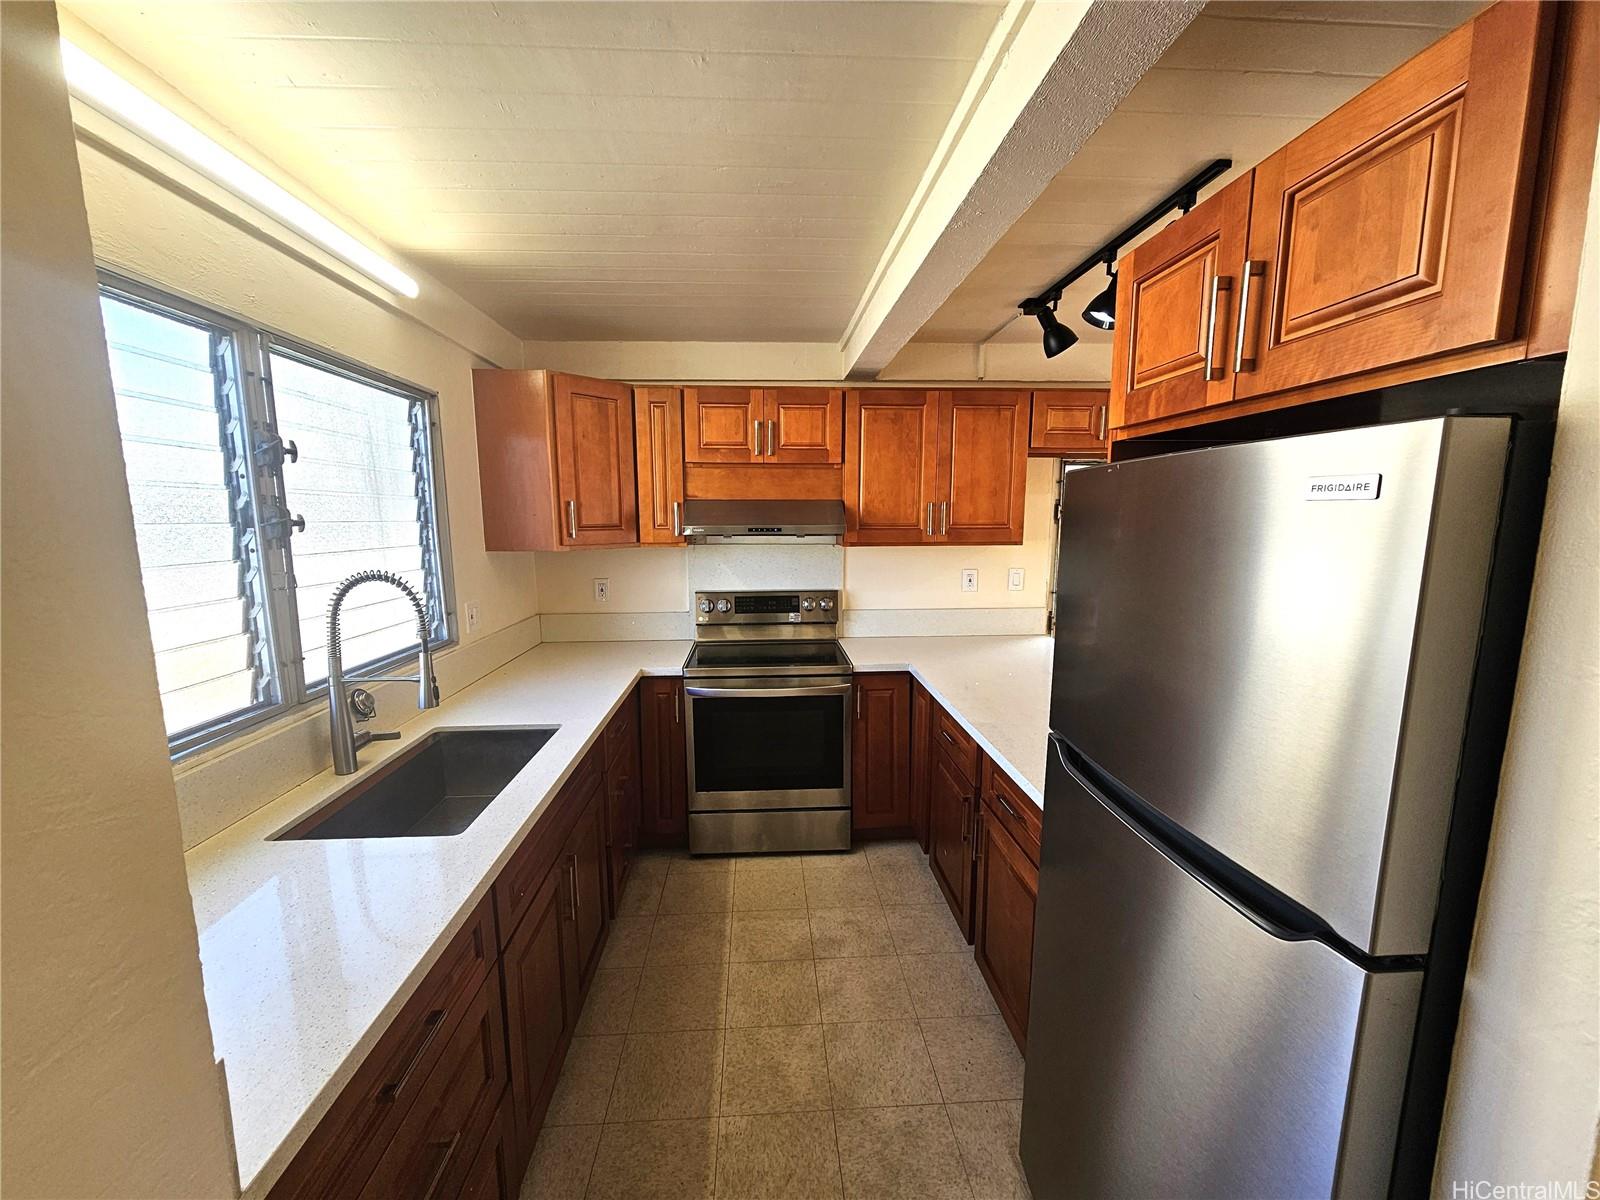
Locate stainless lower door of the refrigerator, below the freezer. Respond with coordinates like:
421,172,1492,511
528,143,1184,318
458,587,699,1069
1021,758,1422,1200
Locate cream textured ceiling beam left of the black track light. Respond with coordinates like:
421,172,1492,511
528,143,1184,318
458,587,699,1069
840,0,1203,379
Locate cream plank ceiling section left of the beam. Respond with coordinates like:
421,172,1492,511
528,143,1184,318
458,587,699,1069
66,0,1002,341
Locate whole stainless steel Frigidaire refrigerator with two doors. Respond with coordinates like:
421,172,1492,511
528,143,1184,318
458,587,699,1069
1021,418,1525,1200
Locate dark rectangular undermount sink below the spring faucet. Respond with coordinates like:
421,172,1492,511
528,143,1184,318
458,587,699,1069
272,725,560,842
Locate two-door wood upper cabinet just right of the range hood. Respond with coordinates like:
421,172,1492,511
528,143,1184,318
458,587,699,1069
845,387,1030,546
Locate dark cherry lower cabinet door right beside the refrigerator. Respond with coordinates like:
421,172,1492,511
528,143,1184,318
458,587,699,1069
973,803,1038,1051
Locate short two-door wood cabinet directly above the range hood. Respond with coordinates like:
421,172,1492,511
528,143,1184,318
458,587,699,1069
683,387,845,466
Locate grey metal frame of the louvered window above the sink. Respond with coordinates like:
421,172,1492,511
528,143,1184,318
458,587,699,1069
96,266,459,763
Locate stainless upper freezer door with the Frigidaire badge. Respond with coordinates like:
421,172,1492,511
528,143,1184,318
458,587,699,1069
1048,418,1509,955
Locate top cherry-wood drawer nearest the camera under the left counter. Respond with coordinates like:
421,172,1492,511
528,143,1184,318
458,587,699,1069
272,896,499,1200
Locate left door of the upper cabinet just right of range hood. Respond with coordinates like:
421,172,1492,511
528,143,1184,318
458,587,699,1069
845,387,944,546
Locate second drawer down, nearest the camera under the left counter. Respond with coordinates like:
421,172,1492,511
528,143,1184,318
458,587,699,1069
362,976,506,1200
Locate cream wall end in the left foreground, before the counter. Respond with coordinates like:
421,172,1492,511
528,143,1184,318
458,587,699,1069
0,3,237,1200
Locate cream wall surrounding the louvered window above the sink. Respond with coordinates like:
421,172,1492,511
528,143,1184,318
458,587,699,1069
74,70,539,846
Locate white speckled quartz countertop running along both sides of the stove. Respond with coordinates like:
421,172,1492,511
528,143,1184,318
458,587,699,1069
187,637,1053,1197
